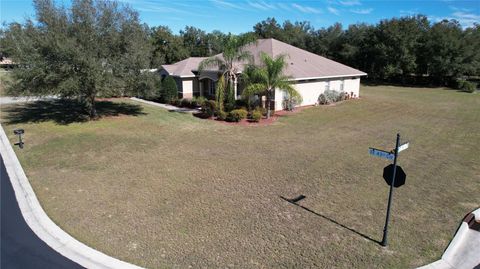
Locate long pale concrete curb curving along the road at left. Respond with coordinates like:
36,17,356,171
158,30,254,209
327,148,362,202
0,124,142,269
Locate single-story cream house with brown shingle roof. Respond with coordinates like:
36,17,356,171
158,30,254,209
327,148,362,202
159,38,366,110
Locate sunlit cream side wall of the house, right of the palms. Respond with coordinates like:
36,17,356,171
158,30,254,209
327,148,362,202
275,78,360,110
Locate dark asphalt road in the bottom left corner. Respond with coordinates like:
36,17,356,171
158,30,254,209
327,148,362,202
0,156,83,269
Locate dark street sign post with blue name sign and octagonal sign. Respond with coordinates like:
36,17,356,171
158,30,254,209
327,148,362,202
368,134,409,247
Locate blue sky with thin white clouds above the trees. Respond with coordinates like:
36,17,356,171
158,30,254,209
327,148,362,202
0,0,480,34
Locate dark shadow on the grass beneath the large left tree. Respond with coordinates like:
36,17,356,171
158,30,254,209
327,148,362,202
3,99,145,125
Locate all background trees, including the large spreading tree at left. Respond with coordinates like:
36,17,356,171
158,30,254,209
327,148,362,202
0,0,480,117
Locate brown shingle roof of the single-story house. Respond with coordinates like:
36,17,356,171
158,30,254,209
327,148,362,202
162,38,366,80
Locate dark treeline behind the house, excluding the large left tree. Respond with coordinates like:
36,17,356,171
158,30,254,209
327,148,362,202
150,15,480,86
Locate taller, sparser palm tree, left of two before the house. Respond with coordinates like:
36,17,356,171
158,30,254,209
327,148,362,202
198,35,254,110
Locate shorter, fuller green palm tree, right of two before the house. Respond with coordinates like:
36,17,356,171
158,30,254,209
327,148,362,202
242,52,302,119
